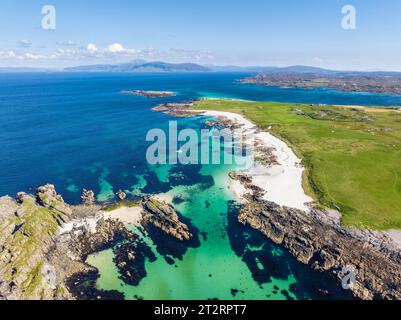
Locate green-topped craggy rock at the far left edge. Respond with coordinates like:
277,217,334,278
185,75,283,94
0,184,71,300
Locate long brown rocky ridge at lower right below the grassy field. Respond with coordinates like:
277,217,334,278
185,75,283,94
238,198,401,299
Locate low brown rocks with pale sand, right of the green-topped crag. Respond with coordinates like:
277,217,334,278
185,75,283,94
48,212,136,300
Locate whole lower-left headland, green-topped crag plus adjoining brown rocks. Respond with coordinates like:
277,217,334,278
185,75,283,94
0,184,136,300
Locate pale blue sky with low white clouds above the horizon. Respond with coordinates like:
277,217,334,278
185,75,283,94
0,0,401,71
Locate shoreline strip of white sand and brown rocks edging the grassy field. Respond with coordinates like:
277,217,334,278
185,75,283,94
183,104,401,300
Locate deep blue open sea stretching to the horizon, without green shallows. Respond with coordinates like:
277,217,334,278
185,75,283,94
0,73,401,202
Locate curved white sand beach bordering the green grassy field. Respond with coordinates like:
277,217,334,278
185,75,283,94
202,111,313,211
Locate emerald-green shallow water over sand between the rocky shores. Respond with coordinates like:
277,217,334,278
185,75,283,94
88,158,304,299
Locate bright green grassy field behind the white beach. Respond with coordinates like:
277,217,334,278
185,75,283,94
191,100,401,230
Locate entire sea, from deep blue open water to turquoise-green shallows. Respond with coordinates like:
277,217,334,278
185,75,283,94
0,73,401,299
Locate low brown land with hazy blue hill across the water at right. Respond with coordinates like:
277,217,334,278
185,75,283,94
241,66,401,94
